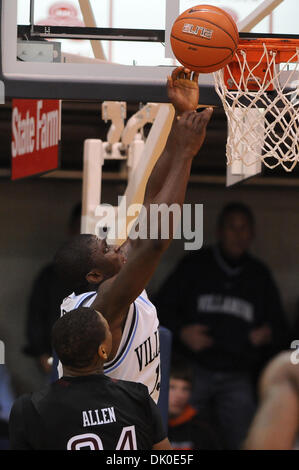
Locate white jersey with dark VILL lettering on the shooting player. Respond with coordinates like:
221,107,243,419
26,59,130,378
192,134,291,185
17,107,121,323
58,291,161,403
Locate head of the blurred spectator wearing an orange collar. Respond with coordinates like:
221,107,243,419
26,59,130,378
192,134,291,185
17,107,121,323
168,365,193,418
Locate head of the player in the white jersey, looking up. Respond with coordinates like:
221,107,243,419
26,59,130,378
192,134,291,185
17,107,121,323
54,234,125,294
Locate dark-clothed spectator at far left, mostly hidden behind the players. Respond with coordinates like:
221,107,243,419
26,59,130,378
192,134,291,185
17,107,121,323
24,203,81,375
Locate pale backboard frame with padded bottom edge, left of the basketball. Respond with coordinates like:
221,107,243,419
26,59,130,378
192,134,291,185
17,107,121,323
0,0,219,104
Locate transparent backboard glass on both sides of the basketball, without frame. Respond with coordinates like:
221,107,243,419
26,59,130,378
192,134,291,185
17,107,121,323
17,0,298,66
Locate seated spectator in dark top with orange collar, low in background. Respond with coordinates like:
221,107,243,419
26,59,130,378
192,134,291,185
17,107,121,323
168,365,219,450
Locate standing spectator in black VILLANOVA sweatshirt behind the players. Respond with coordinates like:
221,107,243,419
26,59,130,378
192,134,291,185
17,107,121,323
155,203,288,449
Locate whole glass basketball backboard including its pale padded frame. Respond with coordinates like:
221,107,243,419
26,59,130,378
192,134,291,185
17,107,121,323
1,0,298,104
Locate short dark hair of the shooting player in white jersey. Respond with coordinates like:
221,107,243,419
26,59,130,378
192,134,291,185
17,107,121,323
54,234,95,294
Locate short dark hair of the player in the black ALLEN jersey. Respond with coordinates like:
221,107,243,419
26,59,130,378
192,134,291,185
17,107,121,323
52,307,106,369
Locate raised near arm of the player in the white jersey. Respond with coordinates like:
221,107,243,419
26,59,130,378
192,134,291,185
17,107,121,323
93,110,211,318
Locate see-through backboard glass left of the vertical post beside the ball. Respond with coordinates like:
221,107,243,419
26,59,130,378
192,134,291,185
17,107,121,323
18,0,172,66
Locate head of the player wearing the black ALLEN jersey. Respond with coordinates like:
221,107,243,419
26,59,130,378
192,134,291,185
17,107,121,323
52,307,112,375
